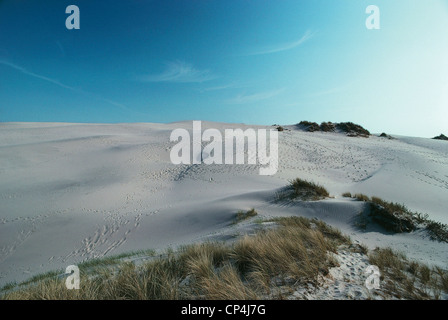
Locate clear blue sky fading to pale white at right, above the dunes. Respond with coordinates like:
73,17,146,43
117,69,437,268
0,0,448,137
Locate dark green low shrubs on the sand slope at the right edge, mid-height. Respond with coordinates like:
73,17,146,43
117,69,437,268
343,192,448,242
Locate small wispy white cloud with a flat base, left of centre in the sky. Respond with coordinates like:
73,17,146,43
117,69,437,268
138,61,217,83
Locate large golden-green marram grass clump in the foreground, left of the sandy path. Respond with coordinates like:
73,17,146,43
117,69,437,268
0,217,348,300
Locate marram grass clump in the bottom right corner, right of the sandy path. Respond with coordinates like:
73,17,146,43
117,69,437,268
369,248,448,300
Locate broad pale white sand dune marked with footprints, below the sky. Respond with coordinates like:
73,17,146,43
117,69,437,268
0,121,448,285
